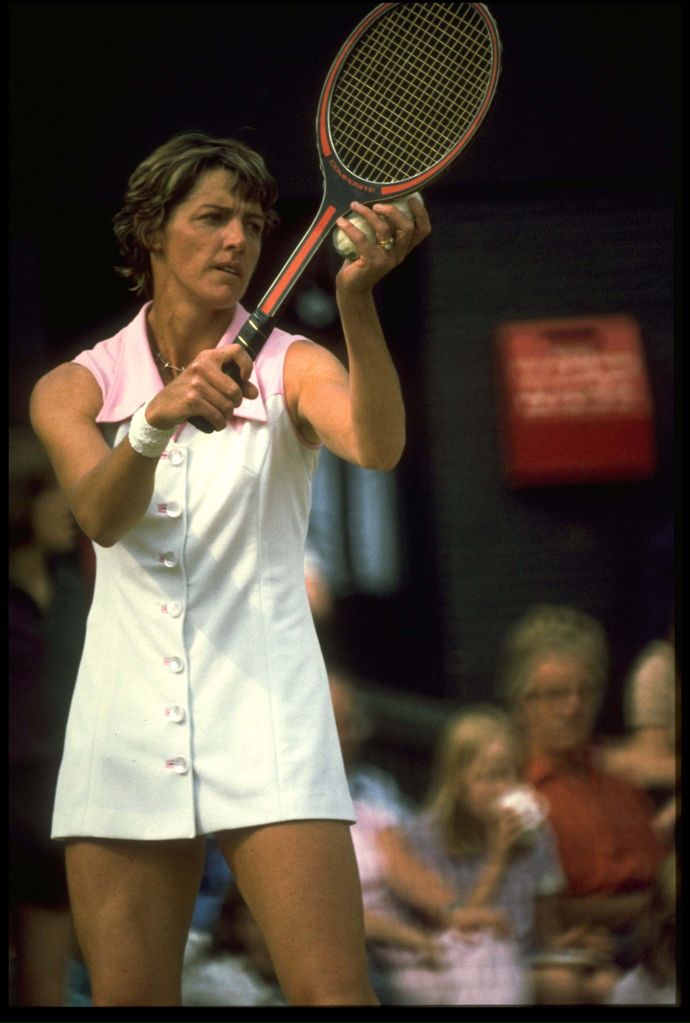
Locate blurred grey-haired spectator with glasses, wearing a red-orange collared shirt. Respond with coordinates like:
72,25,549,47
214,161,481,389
502,605,666,969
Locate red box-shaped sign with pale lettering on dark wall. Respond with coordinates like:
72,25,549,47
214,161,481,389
495,315,655,486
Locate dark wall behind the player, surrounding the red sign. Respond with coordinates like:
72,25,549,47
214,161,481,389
10,3,681,769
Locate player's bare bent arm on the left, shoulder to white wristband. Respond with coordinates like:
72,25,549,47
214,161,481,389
31,362,163,547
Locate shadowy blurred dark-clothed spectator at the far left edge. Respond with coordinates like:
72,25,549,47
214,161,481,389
9,430,86,1006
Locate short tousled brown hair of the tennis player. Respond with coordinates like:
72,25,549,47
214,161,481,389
113,131,277,299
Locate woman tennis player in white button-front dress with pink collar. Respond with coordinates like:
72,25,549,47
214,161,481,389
32,133,430,1006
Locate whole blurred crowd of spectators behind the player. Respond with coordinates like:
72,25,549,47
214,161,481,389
9,431,681,1006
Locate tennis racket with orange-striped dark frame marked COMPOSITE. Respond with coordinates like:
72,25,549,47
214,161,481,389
189,3,501,433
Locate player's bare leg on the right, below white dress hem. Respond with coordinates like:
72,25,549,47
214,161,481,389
216,820,379,1006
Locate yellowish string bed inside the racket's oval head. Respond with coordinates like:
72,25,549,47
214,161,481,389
329,3,497,182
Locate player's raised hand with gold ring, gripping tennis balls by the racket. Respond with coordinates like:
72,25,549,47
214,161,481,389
336,198,431,294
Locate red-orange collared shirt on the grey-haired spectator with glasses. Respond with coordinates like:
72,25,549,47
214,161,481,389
525,753,667,896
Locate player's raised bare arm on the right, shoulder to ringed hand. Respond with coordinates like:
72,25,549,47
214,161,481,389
286,199,431,471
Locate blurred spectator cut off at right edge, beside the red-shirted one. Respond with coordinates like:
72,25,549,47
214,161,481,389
604,639,680,839
